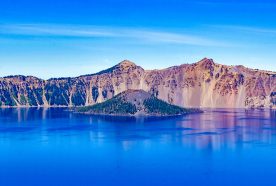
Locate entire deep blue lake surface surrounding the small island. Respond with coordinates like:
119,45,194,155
0,108,276,186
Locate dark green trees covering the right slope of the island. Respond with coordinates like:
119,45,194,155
144,97,192,115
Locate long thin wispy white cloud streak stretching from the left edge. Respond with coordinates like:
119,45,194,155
0,24,230,46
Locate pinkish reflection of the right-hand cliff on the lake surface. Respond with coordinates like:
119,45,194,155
174,110,276,150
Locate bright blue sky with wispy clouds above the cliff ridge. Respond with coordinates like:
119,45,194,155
0,0,276,79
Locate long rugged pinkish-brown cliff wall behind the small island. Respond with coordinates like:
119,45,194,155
0,59,276,108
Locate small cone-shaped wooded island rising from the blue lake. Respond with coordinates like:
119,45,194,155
76,90,200,116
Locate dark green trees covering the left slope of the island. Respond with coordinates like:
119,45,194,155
77,97,137,115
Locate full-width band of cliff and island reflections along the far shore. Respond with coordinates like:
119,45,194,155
0,108,276,151
